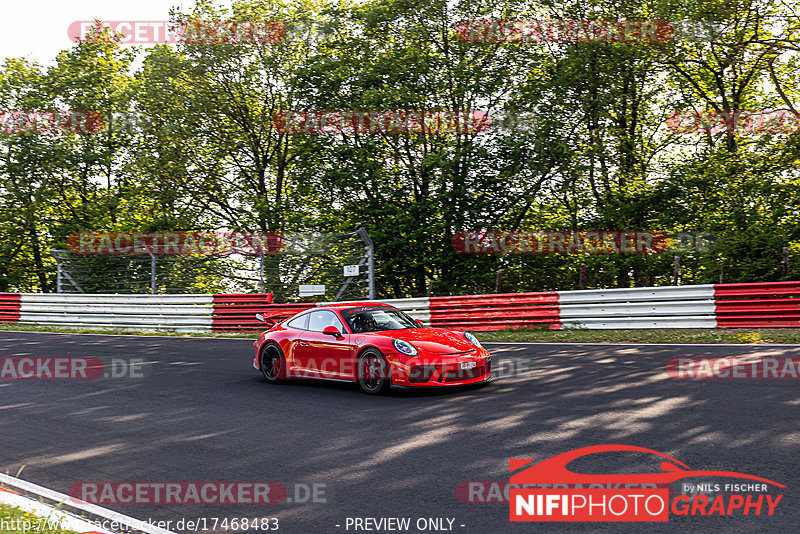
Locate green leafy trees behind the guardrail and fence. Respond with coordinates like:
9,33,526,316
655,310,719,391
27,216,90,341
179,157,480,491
0,0,800,297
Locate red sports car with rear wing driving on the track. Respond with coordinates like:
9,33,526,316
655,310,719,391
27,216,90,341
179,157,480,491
253,302,491,395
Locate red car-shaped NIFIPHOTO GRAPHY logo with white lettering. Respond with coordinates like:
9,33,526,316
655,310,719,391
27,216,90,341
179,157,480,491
509,445,786,522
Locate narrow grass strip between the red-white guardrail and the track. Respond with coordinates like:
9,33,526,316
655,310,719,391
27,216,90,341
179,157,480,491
0,324,800,344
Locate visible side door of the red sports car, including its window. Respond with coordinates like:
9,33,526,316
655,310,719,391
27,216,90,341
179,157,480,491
295,310,351,379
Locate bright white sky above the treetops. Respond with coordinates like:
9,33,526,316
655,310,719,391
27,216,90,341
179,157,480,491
0,0,225,65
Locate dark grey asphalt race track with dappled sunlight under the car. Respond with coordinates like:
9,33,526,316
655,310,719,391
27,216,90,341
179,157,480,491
0,332,800,534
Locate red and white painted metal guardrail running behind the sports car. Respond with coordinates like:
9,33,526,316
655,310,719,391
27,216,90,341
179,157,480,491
0,282,800,332
